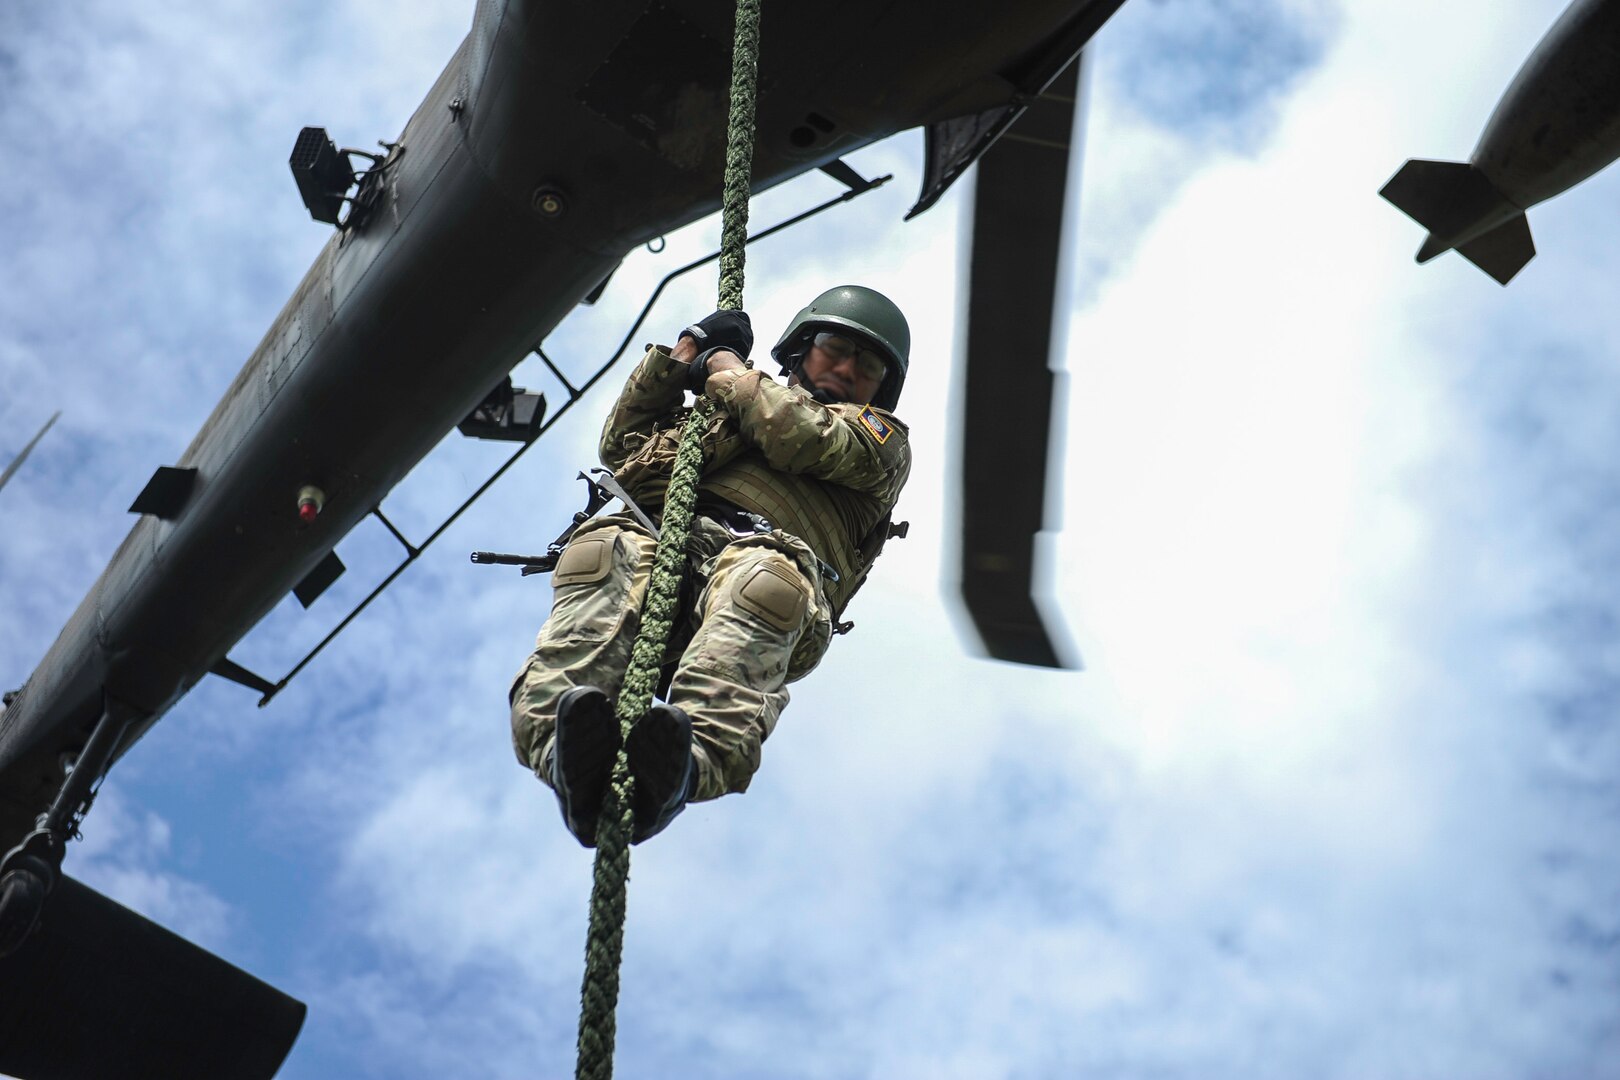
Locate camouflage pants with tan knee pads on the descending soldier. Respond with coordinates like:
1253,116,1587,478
510,515,831,800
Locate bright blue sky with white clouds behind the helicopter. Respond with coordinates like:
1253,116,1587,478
0,0,1620,1080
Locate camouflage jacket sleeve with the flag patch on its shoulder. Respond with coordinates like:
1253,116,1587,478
705,362,910,504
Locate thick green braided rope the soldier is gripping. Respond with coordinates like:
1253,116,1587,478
573,0,760,1080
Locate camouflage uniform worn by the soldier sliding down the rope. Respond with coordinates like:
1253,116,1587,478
512,347,910,800
